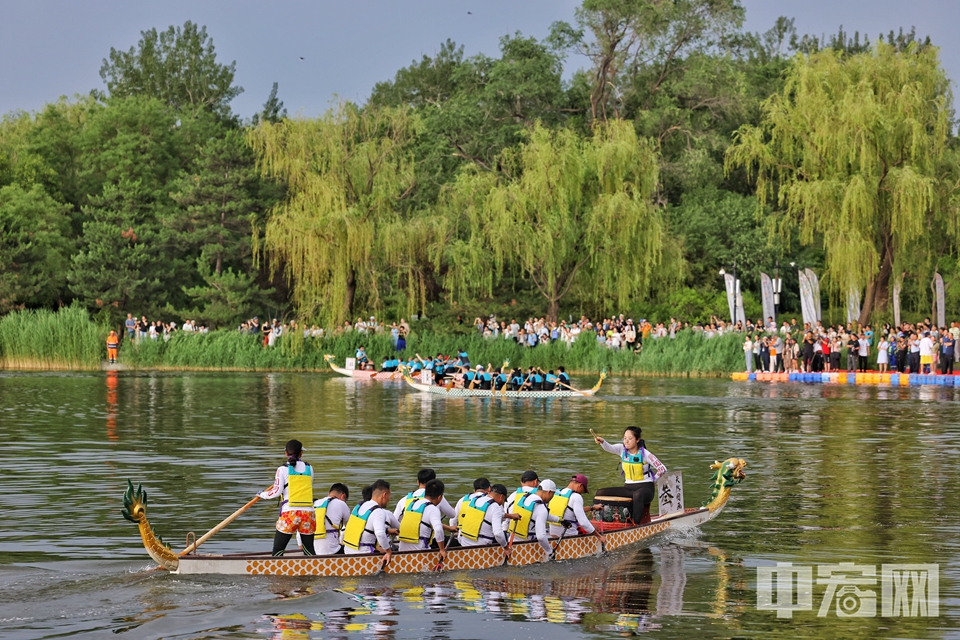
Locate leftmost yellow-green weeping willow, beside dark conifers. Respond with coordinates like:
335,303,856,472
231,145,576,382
249,104,422,323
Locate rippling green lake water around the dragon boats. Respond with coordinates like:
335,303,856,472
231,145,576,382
0,372,960,639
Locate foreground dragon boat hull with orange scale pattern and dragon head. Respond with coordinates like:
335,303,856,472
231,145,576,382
123,458,747,577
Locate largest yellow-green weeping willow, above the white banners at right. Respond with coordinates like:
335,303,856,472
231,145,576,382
726,41,955,323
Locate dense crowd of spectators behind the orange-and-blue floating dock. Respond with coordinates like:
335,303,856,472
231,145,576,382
743,318,960,375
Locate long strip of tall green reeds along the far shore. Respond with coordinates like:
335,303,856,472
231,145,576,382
0,306,743,376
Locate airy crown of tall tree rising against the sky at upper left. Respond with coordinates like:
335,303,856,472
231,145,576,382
100,20,243,118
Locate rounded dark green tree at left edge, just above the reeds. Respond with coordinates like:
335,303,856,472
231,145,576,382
0,185,72,313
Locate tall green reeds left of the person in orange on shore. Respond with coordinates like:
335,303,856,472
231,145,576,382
0,307,109,370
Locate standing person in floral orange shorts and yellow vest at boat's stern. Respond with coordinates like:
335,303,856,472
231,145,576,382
257,440,317,556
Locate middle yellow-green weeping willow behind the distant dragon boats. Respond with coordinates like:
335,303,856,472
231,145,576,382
448,121,664,321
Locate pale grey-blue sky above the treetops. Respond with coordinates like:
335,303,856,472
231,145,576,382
0,0,960,118
